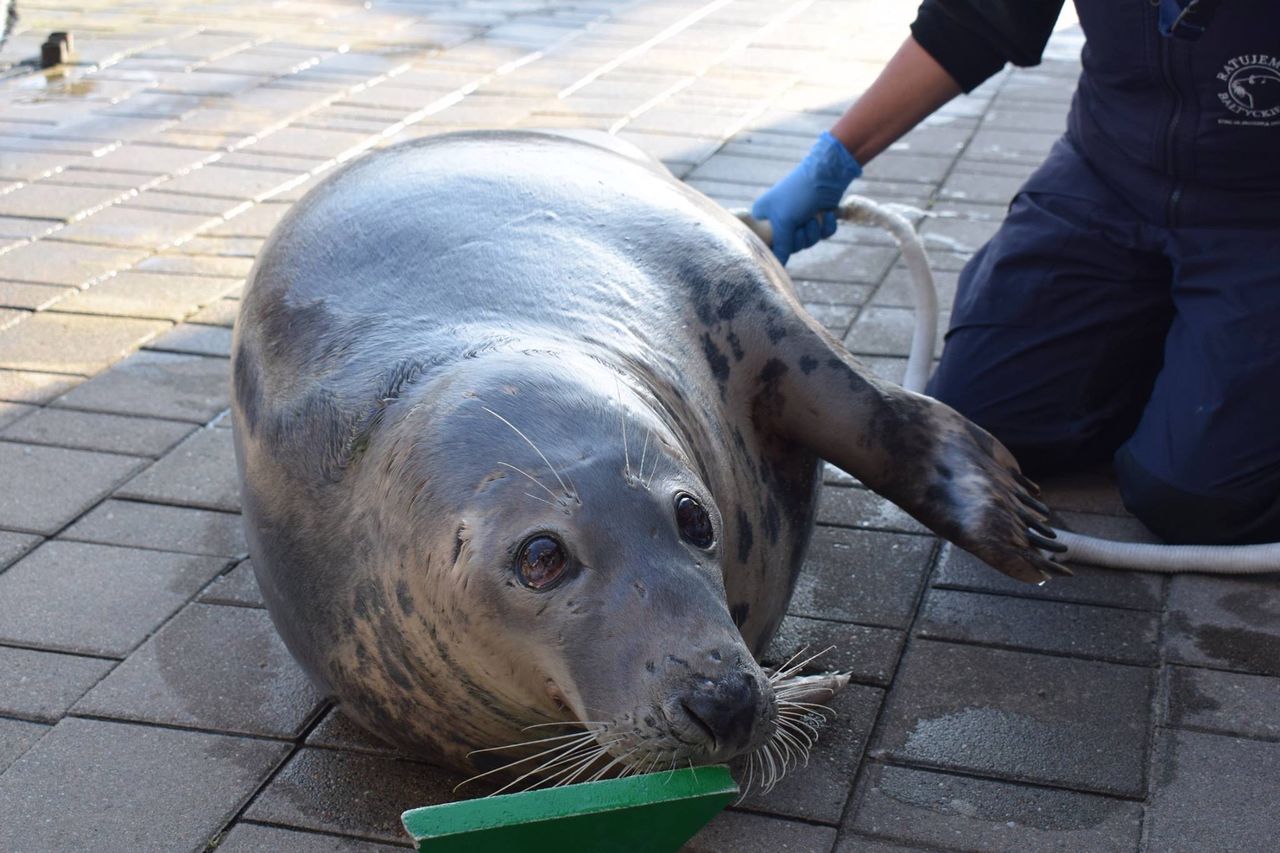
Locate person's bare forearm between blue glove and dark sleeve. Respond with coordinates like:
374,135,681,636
831,36,960,164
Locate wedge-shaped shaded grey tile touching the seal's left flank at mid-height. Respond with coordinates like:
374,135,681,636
116,428,239,512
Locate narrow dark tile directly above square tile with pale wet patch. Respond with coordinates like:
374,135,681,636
916,589,1160,665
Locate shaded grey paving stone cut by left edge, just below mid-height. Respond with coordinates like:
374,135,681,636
0,442,145,535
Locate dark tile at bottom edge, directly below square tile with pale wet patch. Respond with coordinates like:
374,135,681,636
836,763,1142,853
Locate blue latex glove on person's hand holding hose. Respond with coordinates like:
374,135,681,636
751,132,863,264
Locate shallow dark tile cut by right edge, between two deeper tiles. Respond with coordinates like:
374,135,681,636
1164,666,1280,740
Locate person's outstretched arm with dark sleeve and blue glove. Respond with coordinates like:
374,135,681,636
751,0,1062,264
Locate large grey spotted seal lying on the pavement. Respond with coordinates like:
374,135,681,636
233,132,1050,766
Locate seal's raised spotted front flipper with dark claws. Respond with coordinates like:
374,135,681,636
754,316,1071,583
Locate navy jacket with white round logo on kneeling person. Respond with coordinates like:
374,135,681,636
911,0,1280,225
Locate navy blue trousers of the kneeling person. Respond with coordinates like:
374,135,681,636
929,138,1280,543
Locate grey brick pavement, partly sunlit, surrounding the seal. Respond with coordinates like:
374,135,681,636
0,0,1280,853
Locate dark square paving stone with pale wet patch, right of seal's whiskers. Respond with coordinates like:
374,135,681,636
872,640,1152,797
